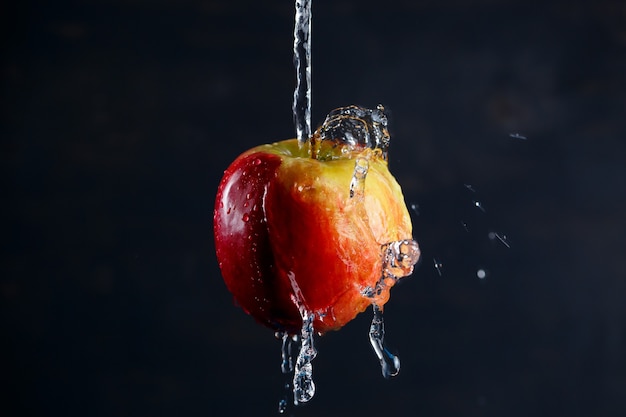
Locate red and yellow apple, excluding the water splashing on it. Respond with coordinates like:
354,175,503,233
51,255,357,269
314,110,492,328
214,139,411,333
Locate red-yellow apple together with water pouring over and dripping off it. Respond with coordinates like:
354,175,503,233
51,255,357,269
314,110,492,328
213,1,420,412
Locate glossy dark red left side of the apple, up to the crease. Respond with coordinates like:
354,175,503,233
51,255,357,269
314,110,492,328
213,153,300,330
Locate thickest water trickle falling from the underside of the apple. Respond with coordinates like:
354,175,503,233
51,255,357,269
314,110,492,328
293,308,317,405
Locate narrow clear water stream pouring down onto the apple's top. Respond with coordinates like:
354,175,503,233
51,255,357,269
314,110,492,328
292,0,312,144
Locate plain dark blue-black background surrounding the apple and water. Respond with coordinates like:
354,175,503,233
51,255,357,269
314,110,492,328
0,0,626,417
